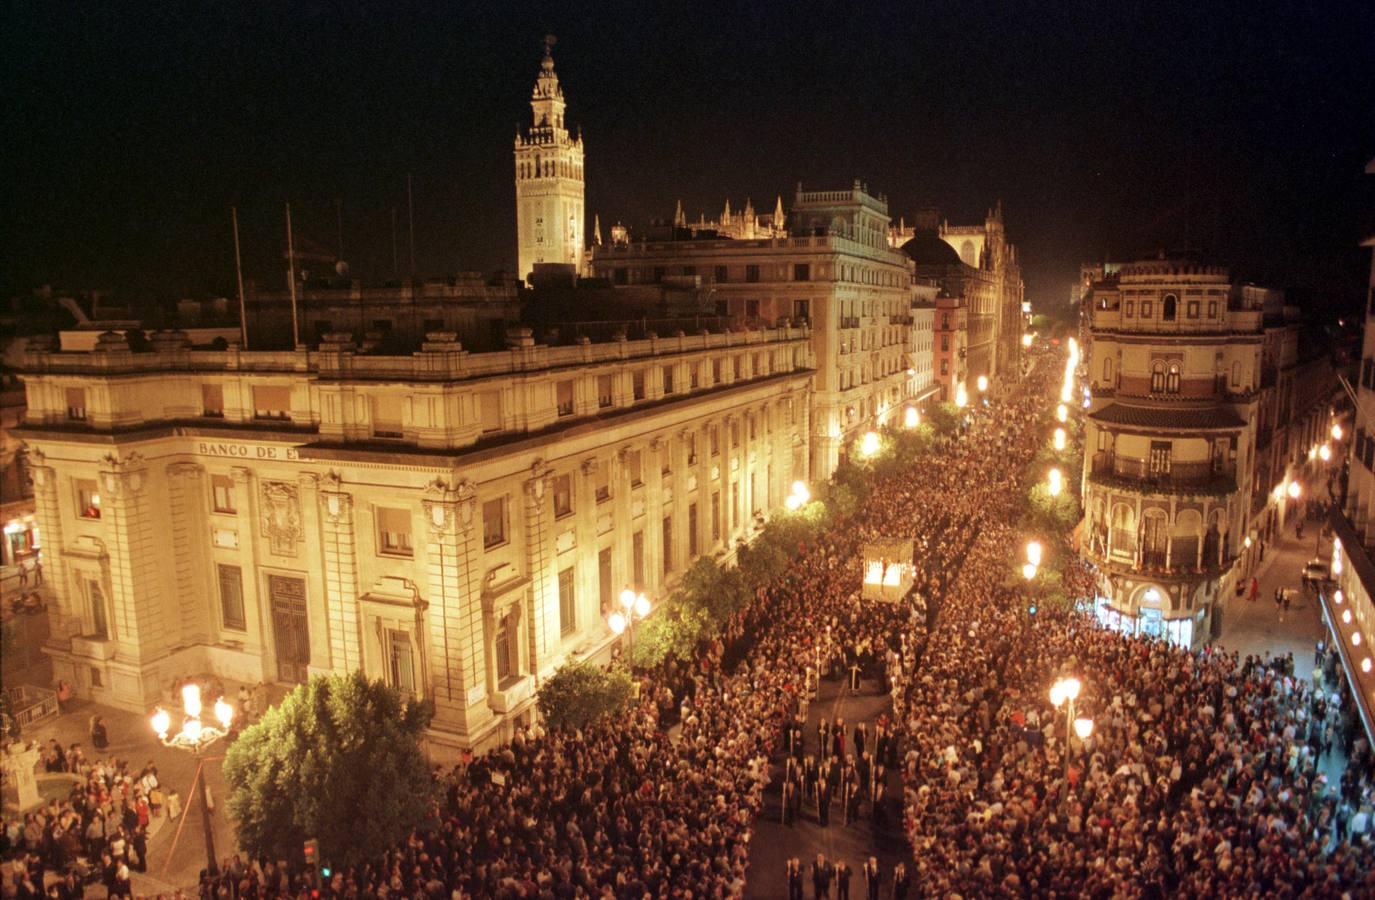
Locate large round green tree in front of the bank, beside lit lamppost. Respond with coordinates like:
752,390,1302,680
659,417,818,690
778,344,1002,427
224,672,433,866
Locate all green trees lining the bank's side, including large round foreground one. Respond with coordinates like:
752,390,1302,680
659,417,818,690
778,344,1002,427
224,405,960,867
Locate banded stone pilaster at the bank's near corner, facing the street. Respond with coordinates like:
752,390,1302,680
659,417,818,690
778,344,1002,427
424,478,491,731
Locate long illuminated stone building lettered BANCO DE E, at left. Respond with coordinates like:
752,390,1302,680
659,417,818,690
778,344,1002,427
17,327,811,746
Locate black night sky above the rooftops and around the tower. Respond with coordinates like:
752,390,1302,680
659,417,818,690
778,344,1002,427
0,0,1375,310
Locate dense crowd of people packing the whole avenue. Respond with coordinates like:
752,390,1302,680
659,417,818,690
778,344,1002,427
11,349,1375,900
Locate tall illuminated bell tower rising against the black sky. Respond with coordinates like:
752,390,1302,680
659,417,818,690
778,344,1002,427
516,34,586,282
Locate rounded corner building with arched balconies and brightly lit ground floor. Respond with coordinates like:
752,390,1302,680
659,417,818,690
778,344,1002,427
1077,260,1264,646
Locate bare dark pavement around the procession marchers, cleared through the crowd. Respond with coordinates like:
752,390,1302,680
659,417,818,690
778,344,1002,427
745,679,910,900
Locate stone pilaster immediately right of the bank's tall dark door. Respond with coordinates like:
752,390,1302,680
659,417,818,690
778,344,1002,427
319,471,363,673
